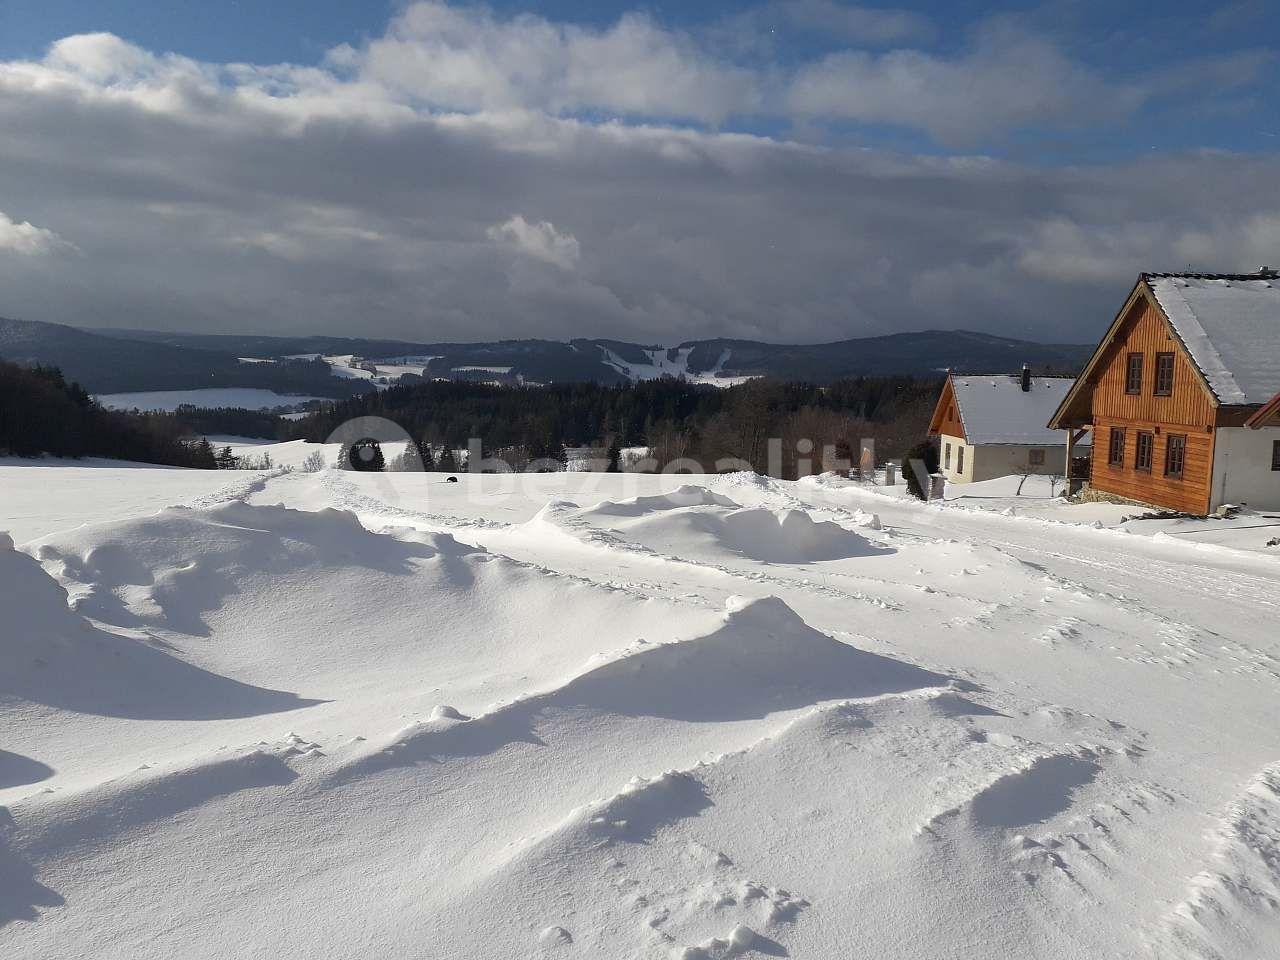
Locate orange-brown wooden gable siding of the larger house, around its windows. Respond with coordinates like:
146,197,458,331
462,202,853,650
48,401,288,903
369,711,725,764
1089,293,1217,513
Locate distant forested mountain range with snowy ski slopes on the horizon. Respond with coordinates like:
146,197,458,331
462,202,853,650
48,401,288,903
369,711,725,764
0,319,1092,397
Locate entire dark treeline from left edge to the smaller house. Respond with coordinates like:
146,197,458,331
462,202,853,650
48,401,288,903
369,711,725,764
0,361,941,477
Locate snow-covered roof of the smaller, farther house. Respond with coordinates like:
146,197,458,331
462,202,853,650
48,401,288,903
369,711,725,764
951,375,1075,447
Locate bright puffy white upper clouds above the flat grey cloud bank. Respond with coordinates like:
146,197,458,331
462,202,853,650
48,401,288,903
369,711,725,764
0,0,1254,145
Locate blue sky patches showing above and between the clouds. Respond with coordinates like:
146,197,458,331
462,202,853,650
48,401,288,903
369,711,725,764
0,0,1280,164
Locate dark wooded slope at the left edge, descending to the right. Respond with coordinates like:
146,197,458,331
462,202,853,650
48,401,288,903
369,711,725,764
0,360,216,470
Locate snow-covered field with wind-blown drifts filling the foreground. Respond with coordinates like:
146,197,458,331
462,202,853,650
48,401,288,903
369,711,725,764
0,461,1280,960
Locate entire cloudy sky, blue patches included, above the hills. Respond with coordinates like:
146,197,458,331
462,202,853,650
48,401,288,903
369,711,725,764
0,0,1280,343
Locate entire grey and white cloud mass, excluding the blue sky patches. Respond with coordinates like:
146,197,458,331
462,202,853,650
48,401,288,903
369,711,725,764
0,4,1280,343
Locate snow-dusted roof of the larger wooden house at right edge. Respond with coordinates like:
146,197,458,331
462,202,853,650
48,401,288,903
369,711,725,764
1147,274,1280,404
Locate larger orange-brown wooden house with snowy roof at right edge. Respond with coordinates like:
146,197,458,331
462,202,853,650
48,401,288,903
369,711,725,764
1050,268,1280,515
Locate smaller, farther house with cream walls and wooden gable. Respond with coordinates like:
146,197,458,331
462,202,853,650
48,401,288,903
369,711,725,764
929,366,1073,484
